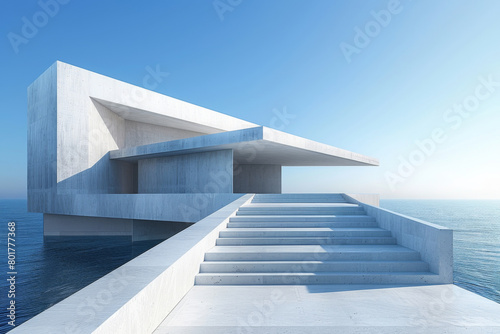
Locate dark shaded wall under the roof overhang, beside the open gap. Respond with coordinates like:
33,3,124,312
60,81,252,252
233,164,281,194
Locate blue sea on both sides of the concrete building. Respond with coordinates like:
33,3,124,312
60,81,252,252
0,200,500,333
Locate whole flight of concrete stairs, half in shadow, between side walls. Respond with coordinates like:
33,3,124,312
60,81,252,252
195,194,438,285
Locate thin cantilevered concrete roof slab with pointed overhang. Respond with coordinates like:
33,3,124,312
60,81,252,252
110,126,379,166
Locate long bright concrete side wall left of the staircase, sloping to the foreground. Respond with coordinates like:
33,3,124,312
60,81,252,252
10,195,253,334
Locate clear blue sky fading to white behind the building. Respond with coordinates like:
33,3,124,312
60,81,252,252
0,0,500,198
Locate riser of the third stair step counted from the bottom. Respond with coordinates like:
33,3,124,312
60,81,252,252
216,237,396,246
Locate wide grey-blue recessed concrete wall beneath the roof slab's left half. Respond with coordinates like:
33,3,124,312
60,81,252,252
138,150,233,194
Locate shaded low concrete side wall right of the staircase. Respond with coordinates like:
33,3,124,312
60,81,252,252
345,195,453,283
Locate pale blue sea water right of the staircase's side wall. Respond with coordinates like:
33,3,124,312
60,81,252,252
380,200,500,304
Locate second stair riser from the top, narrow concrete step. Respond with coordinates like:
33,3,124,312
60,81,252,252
236,207,365,216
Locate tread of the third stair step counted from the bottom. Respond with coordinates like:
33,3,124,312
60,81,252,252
219,224,391,238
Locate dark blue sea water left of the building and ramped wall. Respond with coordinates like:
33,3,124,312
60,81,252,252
0,200,161,333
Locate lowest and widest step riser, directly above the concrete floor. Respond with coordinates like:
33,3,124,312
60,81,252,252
195,272,439,285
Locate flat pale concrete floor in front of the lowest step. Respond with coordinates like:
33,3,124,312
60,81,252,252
154,284,500,334
